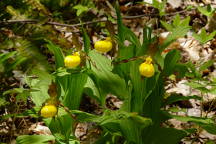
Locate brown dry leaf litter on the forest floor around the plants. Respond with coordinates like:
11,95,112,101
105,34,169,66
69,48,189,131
0,0,216,144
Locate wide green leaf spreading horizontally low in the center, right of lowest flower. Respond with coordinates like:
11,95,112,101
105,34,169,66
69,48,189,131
71,110,152,140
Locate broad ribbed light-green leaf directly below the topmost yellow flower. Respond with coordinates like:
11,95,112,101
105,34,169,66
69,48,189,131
89,50,128,102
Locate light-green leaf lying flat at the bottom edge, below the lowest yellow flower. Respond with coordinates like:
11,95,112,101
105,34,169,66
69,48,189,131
16,135,55,144
